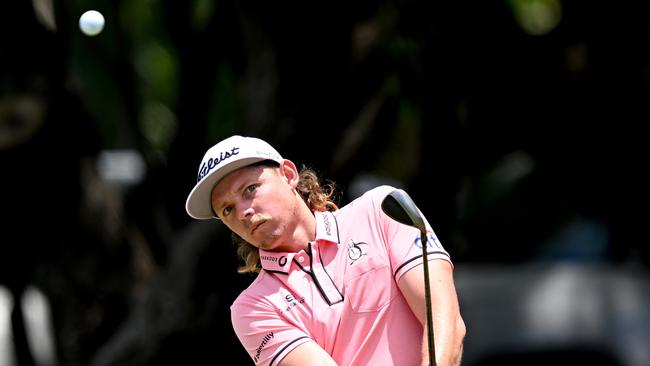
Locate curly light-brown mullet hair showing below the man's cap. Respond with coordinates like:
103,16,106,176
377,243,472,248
232,164,338,273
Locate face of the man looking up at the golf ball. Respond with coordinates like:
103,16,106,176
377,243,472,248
212,160,301,251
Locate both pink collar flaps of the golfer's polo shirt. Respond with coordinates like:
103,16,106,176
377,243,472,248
259,211,339,273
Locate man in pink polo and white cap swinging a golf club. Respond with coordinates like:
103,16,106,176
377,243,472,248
186,136,465,366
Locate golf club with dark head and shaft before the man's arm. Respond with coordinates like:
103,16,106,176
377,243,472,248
381,189,436,366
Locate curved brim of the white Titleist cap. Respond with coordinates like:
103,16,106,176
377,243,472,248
185,156,267,220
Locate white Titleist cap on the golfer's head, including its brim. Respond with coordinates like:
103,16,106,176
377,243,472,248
185,135,283,220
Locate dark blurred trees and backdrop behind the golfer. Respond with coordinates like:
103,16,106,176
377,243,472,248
0,0,650,366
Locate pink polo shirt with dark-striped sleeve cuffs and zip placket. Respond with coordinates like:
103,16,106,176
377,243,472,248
231,186,451,366
